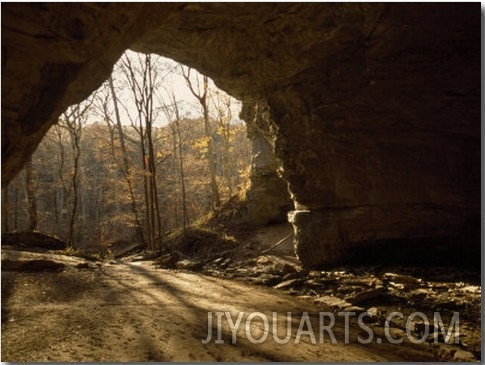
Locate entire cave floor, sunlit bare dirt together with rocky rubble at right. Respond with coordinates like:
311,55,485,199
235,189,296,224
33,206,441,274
1,225,481,362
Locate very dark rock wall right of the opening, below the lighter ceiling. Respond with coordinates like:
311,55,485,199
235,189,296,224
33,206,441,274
268,6,480,266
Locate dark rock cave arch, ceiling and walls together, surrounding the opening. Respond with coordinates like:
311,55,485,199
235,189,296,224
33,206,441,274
2,3,481,268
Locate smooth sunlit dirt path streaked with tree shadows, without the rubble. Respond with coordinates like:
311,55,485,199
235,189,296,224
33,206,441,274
2,262,438,362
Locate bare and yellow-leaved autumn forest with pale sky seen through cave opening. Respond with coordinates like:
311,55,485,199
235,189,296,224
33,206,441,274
2,51,250,252
